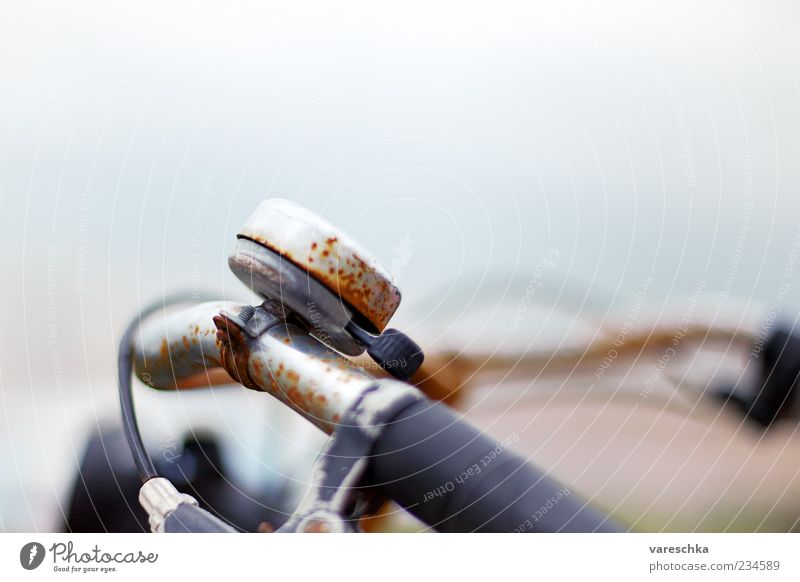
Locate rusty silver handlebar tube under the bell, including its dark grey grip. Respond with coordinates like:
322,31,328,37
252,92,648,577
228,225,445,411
134,303,617,532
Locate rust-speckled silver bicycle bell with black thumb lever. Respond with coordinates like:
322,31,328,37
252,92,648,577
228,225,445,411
228,199,424,379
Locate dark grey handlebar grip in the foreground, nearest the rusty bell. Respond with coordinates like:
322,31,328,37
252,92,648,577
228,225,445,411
365,400,620,532
